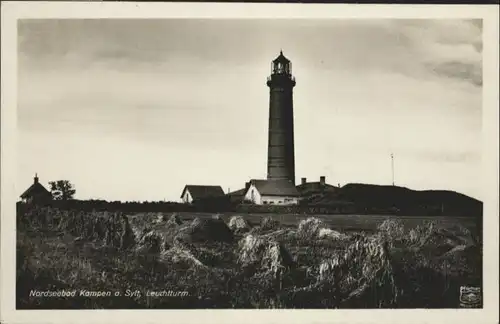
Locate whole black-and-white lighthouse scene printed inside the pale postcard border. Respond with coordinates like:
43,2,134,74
2,2,498,324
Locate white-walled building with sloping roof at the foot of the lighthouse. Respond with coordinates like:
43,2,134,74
243,180,300,205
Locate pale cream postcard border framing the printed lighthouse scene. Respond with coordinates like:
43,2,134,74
0,2,499,324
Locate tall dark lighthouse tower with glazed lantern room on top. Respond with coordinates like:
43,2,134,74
267,51,295,185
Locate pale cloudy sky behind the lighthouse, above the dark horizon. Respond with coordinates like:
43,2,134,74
16,19,482,201
